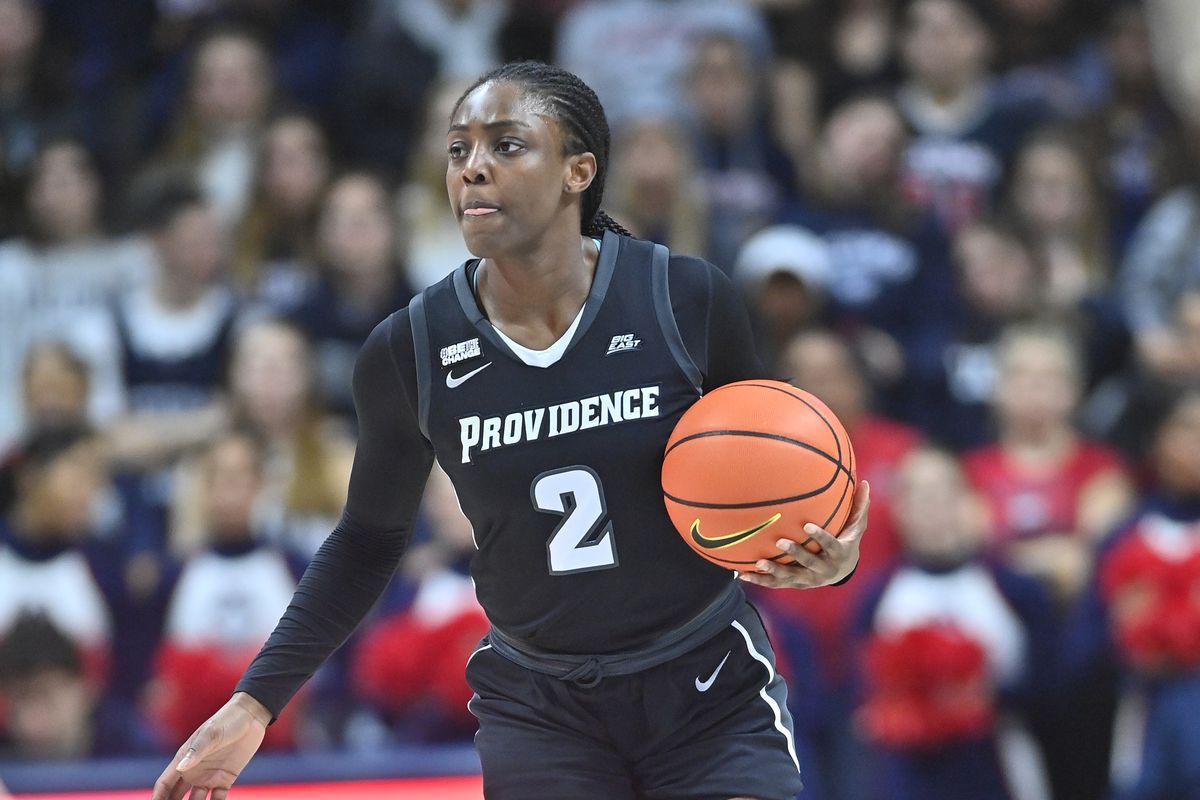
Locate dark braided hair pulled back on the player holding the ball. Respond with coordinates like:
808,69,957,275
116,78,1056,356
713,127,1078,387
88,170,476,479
454,61,632,236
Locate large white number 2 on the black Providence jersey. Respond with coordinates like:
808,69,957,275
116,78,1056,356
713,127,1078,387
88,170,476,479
529,467,617,575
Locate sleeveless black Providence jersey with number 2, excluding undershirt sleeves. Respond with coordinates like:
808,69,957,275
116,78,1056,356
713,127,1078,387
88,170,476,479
409,233,732,654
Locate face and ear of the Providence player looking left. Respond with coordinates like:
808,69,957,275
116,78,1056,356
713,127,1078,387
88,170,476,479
446,83,594,258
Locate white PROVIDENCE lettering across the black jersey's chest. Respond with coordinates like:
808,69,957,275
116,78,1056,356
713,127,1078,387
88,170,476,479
458,386,660,464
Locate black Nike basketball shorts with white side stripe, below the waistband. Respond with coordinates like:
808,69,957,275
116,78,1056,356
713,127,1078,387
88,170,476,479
467,603,800,800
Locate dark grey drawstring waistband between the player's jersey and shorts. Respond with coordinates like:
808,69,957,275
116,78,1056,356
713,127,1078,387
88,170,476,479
487,581,745,687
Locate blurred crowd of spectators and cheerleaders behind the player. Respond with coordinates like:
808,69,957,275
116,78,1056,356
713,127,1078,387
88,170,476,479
0,0,1200,800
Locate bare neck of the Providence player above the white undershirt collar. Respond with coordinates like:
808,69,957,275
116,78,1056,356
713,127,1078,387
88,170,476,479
475,235,599,349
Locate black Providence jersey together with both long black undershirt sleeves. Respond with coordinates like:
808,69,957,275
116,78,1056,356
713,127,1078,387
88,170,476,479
231,233,766,714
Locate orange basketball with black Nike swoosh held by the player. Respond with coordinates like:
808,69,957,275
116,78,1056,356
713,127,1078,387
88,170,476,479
662,380,858,572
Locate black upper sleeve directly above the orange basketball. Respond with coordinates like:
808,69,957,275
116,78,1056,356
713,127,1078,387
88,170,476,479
670,255,769,392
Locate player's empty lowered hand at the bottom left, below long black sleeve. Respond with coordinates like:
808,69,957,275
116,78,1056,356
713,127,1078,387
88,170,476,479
150,692,271,800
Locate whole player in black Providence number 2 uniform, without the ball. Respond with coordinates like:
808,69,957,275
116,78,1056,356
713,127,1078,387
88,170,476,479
154,62,869,800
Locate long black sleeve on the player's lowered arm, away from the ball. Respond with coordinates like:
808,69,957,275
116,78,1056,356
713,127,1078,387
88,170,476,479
236,312,433,716
